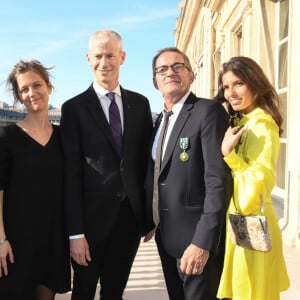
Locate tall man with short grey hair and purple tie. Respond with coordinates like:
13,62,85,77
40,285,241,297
61,30,152,300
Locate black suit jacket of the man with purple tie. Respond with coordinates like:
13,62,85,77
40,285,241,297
61,86,153,241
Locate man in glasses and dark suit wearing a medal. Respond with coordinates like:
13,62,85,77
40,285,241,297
145,48,232,300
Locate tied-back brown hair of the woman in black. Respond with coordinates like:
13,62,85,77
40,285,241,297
7,59,53,104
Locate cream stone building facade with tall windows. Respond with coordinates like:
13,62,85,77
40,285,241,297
174,0,300,249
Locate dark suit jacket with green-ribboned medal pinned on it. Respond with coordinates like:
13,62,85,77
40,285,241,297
146,93,232,258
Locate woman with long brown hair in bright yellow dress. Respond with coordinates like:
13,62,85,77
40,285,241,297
216,57,290,300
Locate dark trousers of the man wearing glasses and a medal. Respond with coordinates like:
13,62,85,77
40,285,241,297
155,228,224,300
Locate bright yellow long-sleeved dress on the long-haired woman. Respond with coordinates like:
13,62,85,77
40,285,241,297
217,108,290,300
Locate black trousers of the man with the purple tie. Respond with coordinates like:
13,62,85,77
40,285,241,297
71,199,141,300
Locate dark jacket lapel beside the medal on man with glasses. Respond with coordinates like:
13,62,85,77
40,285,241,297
160,94,195,172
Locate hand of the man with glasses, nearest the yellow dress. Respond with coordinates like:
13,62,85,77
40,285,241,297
180,244,209,275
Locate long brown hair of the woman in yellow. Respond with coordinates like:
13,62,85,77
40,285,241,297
215,56,282,134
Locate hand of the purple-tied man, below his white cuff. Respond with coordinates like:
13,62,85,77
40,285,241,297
70,237,92,266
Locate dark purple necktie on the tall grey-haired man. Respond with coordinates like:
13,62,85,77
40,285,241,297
106,92,123,154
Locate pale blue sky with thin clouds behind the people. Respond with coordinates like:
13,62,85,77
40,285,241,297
0,0,181,112
